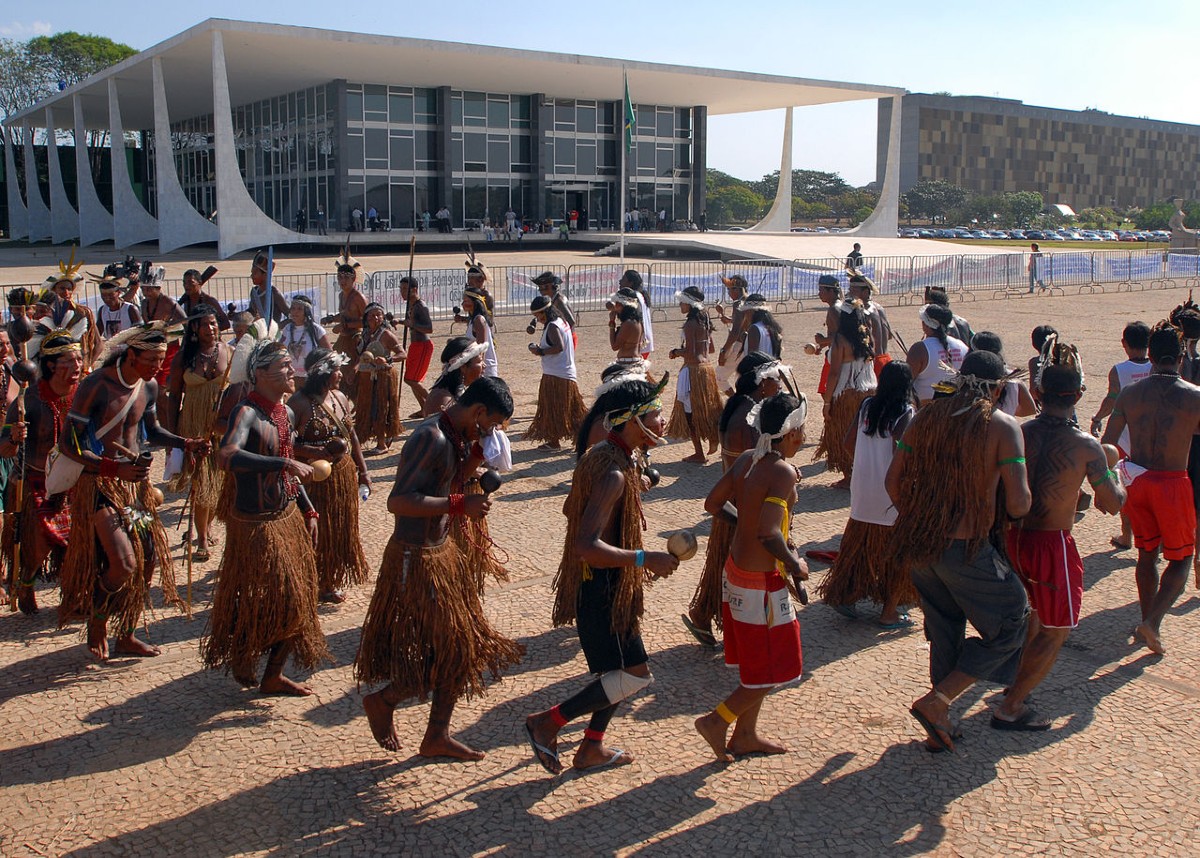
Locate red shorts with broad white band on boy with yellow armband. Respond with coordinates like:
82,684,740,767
721,557,804,688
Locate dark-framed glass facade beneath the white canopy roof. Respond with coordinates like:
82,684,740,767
164,80,695,230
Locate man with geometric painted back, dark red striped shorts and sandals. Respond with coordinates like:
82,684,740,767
991,343,1126,730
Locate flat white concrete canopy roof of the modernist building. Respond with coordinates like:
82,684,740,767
10,18,905,128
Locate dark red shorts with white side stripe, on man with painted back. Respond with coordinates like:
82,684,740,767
1008,527,1084,629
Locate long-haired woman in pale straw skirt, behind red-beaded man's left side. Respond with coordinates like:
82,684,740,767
166,304,233,563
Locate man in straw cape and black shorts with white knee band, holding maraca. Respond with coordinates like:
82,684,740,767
524,373,678,774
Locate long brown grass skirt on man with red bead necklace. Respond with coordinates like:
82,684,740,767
200,504,331,678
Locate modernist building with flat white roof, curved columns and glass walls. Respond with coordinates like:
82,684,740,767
5,19,904,257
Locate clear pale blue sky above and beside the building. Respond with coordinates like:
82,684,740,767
0,0,1200,185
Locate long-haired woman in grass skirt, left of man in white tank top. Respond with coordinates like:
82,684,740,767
812,300,875,488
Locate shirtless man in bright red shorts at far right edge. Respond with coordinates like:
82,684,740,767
1104,320,1200,655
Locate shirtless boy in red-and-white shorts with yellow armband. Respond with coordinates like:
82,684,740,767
696,394,809,762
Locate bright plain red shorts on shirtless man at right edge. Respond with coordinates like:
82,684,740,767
1124,470,1196,560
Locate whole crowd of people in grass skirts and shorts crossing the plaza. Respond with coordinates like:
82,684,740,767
0,247,1200,774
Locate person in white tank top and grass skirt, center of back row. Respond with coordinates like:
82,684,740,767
524,295,588,450
